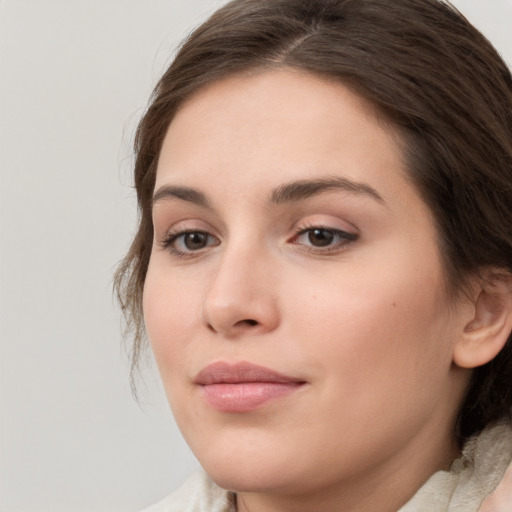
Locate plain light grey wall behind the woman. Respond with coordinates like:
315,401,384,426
0,0,512,512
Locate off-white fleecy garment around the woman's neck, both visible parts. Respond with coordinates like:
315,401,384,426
142,422,512,512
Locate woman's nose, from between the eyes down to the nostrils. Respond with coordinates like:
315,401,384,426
203,243,279,338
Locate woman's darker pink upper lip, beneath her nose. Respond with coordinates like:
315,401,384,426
194,361,304,386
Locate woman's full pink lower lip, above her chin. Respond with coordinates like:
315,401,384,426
202,382,303,412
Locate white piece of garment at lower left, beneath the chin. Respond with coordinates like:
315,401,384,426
138,470,233,512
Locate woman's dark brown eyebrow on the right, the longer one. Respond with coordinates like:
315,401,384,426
270,176,386,205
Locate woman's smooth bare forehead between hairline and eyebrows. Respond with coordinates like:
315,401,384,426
156,69,405,206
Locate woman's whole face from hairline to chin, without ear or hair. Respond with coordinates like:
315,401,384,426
144,69,465,506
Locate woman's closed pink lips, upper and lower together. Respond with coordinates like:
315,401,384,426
195,362,305,412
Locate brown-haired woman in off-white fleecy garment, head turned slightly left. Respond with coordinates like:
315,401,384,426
117,0,512,512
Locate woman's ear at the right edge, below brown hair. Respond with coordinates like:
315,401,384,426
453,270,512,368
